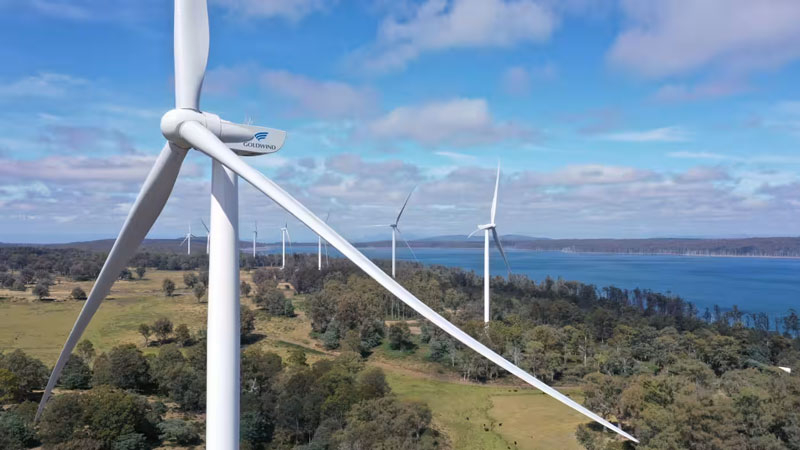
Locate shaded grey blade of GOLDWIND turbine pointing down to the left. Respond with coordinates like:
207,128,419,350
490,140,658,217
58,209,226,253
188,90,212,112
35,143,187,420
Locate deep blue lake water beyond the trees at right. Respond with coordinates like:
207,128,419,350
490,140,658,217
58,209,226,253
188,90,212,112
268,248,800,316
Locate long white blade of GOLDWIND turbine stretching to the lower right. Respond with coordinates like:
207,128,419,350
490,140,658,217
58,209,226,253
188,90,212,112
180,122,639,442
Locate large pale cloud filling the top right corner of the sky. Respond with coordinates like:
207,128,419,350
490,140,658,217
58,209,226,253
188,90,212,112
608,0,800,77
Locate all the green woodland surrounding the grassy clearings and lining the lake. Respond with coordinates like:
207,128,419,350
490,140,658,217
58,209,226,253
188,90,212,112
0,248,800,449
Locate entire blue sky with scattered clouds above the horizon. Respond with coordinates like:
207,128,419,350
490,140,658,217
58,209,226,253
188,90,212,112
0,0,800,242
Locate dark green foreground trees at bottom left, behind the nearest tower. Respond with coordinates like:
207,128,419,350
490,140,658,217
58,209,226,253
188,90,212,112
0,342,440,450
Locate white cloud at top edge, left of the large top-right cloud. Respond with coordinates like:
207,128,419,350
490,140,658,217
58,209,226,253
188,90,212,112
361,0,558,72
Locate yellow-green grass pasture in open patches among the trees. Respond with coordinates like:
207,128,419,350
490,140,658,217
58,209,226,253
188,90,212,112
0,270,586,450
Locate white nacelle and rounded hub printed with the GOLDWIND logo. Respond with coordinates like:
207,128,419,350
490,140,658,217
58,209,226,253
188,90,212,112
161,108,286,156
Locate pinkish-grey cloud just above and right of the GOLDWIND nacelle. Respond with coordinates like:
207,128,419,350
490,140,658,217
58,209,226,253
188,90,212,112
261,70,377,118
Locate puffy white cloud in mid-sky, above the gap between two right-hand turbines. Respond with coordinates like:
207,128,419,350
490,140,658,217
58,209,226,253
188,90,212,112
367,98,532,146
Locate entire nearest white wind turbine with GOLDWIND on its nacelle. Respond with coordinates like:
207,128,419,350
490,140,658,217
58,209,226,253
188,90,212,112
36,0,638,450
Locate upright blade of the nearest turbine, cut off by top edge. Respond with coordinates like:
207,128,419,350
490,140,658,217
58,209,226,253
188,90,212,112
174,0,208,110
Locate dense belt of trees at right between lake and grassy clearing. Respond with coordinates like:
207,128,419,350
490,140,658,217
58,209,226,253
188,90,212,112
287,256,800,449
